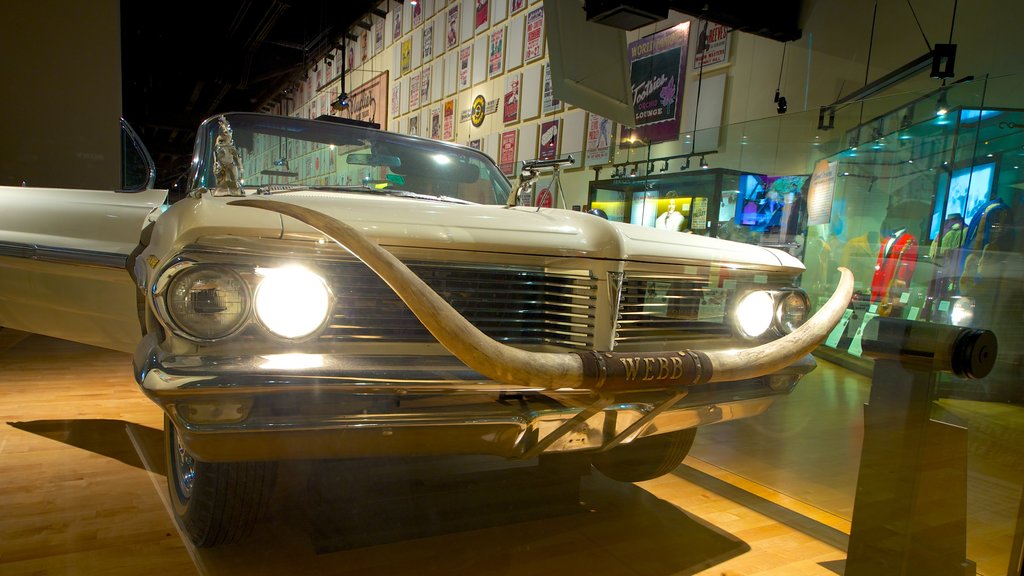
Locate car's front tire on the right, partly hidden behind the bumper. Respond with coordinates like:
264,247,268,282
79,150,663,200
591,428,697,482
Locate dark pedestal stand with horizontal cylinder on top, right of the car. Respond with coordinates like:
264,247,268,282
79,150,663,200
846,318,996,576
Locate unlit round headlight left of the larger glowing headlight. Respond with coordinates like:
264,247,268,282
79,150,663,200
167,266,249,340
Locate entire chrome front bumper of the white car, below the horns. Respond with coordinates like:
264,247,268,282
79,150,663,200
134,335,814,461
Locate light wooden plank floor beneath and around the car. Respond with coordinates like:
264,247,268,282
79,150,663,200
0,331,1020,576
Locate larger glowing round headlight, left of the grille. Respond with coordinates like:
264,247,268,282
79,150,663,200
254,266,331,338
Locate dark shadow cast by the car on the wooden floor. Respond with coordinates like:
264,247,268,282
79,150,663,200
11,419,750,576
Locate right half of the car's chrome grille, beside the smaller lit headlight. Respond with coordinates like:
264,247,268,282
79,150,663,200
615,274,735,344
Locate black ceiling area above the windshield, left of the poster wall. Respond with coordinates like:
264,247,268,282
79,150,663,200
121,0,377,183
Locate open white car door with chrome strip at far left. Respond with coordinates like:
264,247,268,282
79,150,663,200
0,121,167,352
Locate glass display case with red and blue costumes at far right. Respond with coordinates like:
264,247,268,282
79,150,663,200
804,104,1024,401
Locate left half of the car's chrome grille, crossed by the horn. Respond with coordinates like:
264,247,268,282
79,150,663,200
321,262,597,348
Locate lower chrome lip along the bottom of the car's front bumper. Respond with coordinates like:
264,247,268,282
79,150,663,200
169,396,775,461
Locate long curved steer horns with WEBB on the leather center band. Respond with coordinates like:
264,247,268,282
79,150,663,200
228,199,853,392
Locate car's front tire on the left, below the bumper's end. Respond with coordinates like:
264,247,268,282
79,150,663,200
164,415,278,547
